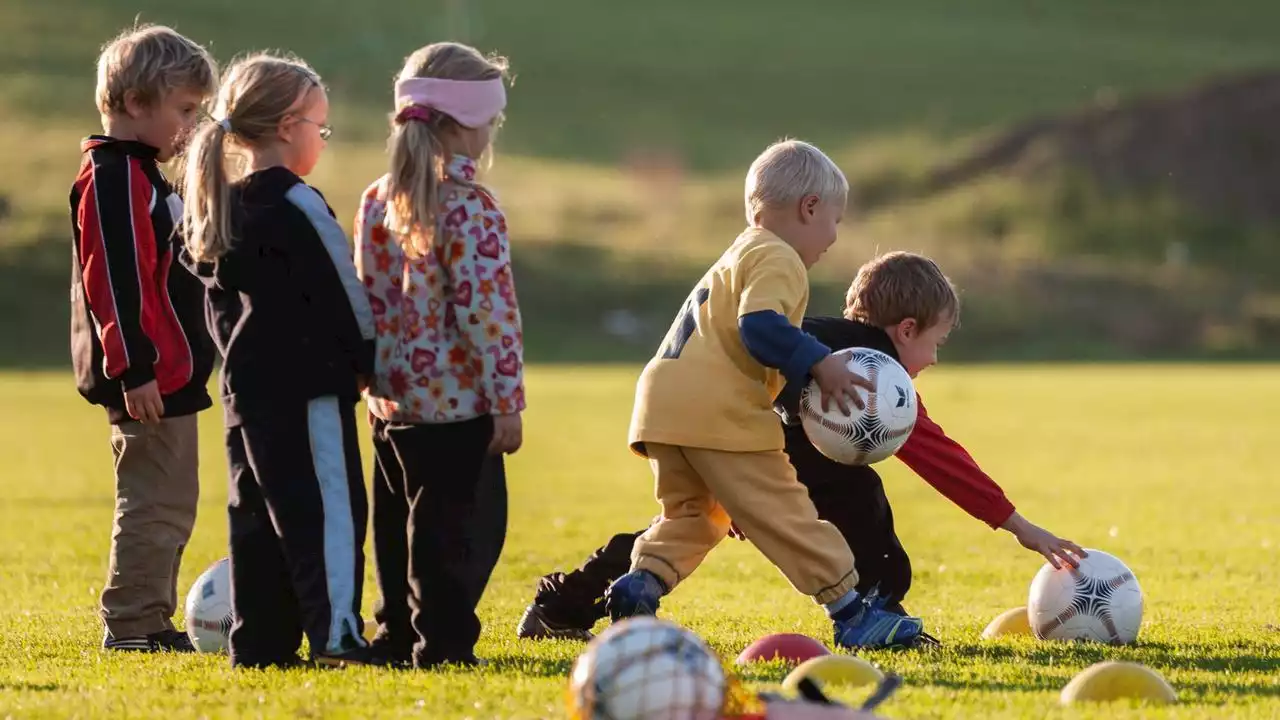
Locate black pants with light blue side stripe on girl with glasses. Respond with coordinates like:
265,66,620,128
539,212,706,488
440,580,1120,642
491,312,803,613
227,397,369,666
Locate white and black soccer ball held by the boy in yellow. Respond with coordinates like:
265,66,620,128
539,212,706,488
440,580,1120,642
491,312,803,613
800,347,918,465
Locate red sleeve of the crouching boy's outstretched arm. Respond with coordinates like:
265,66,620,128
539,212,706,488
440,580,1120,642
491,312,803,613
897,397,1014,528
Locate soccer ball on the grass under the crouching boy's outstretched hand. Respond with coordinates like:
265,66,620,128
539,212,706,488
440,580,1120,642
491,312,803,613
1027,548,1143,644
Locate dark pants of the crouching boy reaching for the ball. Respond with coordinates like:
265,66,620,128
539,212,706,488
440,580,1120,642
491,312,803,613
534,448,911,628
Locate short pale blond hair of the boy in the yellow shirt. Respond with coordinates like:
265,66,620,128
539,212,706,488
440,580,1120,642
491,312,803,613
746,140,849,224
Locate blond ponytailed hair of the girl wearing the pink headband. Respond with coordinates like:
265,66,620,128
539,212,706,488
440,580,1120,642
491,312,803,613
385,42,507,256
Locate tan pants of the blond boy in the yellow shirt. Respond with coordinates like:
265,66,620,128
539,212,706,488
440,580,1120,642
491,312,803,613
631,443,858,603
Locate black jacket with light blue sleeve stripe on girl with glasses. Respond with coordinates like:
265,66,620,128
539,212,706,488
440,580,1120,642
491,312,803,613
184,167,374,427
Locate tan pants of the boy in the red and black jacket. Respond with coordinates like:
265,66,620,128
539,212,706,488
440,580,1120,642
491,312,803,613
101,415,200,638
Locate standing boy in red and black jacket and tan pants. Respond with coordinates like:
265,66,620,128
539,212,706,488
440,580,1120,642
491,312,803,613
70,27,216,652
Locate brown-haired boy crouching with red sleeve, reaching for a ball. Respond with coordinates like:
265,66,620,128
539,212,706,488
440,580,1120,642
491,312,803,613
516,252,1084,639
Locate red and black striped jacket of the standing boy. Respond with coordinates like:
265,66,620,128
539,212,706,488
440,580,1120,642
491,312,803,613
70,136,214,423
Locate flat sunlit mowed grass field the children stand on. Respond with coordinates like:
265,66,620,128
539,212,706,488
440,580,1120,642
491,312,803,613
0,366,1280,719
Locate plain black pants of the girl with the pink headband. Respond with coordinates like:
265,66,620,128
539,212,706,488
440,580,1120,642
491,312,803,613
374,415,507,666
